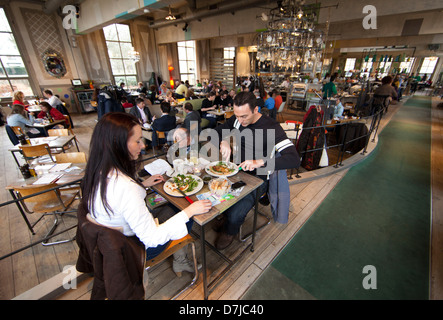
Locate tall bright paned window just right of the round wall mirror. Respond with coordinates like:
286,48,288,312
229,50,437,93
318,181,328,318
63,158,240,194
103,24,137,87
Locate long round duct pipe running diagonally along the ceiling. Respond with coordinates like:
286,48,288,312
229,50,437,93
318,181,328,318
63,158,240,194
151,0,270,28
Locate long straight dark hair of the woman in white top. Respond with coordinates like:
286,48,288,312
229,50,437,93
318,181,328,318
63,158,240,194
82,112,143,215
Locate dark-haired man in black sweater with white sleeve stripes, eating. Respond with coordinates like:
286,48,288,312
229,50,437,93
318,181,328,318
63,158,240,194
215,91,300,250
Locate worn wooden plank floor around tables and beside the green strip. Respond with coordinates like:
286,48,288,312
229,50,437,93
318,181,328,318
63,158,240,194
0,95,443,300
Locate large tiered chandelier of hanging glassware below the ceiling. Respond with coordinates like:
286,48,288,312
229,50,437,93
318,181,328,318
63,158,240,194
257,0,324,72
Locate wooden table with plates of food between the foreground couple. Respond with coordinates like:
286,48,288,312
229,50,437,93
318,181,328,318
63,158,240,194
152,171,263,300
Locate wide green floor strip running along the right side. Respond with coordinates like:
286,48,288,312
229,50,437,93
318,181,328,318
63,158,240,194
244,96,431,300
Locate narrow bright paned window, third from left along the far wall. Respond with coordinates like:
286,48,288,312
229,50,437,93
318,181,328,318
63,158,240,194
177,40,197,86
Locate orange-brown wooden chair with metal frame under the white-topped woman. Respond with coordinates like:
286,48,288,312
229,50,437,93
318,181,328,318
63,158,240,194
145,234,198,300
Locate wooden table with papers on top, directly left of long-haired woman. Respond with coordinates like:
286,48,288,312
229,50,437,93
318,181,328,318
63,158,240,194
5,163,86,234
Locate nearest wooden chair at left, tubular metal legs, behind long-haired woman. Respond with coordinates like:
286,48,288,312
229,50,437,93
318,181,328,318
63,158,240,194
14,183,78,246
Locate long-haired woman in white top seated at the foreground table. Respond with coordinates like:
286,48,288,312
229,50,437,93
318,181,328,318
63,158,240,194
81,112,211,273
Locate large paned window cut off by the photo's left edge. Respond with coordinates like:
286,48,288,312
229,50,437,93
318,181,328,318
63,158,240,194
0,8,34,97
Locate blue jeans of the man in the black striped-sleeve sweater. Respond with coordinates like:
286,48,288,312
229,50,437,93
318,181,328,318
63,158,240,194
224,180,268,235
